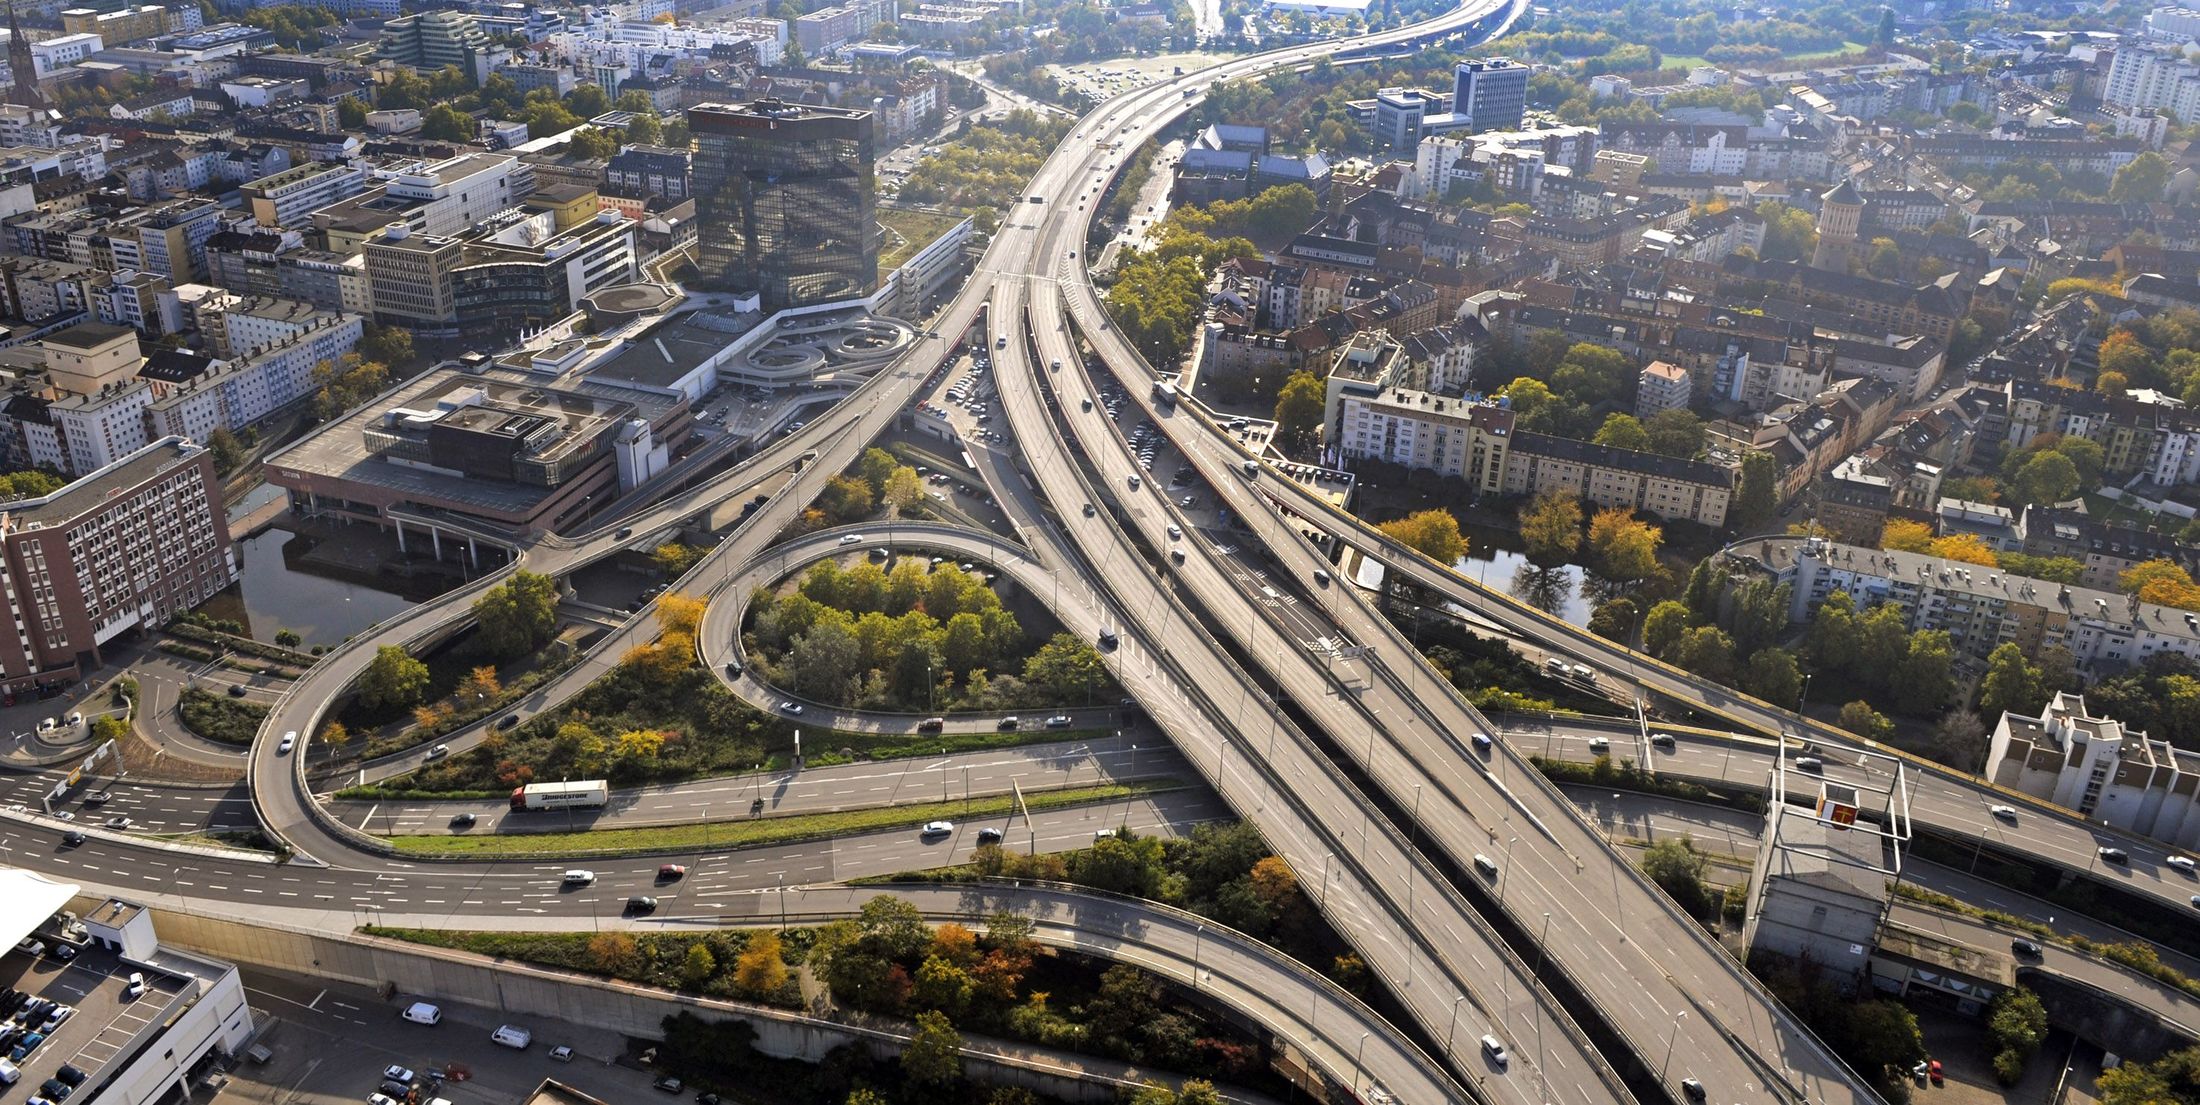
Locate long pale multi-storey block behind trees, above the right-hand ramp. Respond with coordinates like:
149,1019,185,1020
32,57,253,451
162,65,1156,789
1720,537,2200,674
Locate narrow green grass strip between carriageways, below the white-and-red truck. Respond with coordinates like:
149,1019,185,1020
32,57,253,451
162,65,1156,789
389,779,1184,856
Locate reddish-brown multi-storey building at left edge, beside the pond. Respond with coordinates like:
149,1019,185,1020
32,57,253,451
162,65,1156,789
0,438,238,687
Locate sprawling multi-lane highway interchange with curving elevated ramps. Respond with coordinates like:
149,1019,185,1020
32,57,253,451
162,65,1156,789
0,4,2191,1103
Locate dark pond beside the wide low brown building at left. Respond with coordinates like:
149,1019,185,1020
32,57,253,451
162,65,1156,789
200,528,433,647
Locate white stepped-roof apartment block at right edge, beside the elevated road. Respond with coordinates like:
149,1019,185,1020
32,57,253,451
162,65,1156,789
1984,691,2200,847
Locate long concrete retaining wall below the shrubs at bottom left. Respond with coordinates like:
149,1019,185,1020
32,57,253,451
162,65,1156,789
135,911,1161,1105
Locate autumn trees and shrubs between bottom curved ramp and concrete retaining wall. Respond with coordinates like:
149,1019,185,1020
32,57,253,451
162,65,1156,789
365,894,1283,1105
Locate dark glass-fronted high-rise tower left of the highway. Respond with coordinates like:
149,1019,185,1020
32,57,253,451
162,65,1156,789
686,99,878,310
